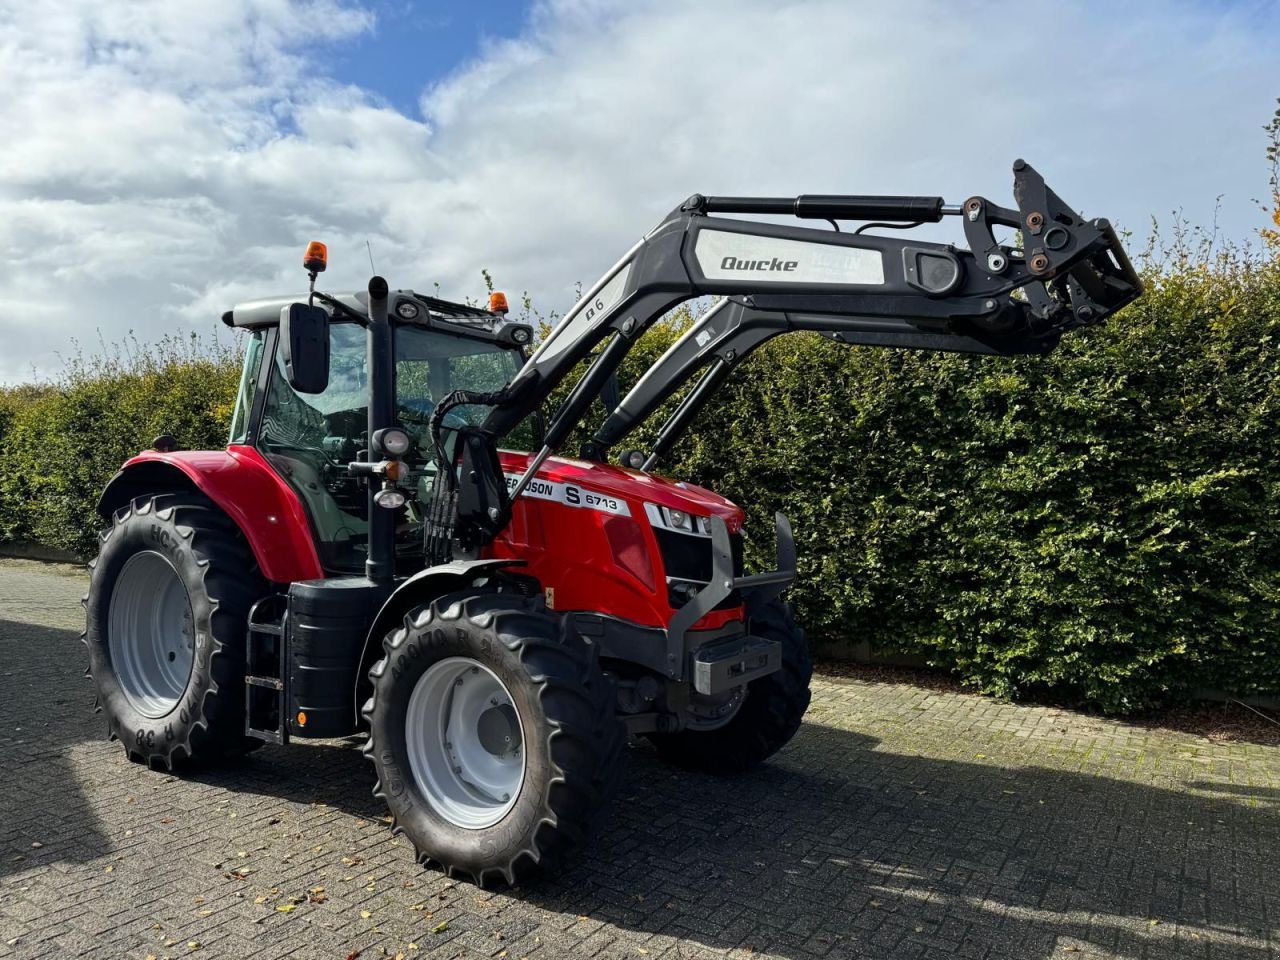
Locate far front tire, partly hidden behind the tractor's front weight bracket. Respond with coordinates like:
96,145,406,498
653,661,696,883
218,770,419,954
648,599,813,774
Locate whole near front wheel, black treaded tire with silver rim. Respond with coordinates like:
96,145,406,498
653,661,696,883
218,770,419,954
364,593,626,886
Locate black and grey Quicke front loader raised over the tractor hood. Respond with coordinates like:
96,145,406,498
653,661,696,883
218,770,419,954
473,160,1142,497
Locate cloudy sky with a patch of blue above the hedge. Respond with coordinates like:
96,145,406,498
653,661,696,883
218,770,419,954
0,0,1280,383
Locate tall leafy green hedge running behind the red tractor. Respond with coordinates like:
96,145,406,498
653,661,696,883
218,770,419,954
0,259,1280,712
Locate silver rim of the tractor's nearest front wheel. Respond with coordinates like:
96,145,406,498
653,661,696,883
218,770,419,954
404,657,525,829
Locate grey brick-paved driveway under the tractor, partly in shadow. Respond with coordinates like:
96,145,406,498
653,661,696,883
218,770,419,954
0,562,1280,960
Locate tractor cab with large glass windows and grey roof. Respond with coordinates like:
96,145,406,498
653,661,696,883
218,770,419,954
224,291,540,576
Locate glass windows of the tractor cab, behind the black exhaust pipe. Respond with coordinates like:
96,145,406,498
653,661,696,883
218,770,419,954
259,323,524,572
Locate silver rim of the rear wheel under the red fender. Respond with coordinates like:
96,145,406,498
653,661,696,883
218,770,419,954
108,550,196,719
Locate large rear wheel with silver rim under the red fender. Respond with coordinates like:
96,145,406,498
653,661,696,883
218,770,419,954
83,493,266,769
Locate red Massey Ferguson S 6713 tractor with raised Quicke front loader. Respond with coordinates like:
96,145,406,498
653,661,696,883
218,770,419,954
86,161,1140,883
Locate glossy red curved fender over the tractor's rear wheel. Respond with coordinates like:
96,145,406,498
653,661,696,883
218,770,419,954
97,445,324,584
